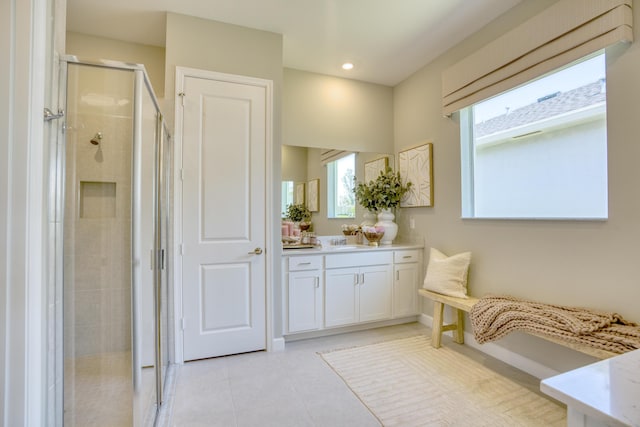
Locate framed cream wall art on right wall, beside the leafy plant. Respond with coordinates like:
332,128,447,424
398,142,433,208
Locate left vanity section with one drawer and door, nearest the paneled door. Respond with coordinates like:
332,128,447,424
286,255,324,333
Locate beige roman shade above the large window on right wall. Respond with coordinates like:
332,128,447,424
442,0,633,115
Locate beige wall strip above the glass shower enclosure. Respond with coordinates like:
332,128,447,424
65,31,164,98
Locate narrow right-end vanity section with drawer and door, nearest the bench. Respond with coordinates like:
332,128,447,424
393,249,422,318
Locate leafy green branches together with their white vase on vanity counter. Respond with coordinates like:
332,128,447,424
353,167,412,245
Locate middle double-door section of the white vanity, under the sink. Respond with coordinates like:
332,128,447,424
324,252,393,328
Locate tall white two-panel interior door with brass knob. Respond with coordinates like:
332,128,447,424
182,72,269,360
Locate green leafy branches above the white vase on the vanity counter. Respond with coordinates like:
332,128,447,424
353,167,411,212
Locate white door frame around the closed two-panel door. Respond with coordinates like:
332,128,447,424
173,66,279,364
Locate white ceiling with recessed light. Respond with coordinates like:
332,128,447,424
67,0,522,86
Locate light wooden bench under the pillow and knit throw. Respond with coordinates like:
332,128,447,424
418,289,618,359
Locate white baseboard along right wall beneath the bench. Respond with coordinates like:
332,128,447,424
418,314,560,379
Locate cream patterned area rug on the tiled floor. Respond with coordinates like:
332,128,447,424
321,336,566,427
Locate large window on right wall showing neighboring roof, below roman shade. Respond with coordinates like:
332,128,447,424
460,52,607,219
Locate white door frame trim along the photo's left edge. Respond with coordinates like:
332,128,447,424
0,0,50,426
